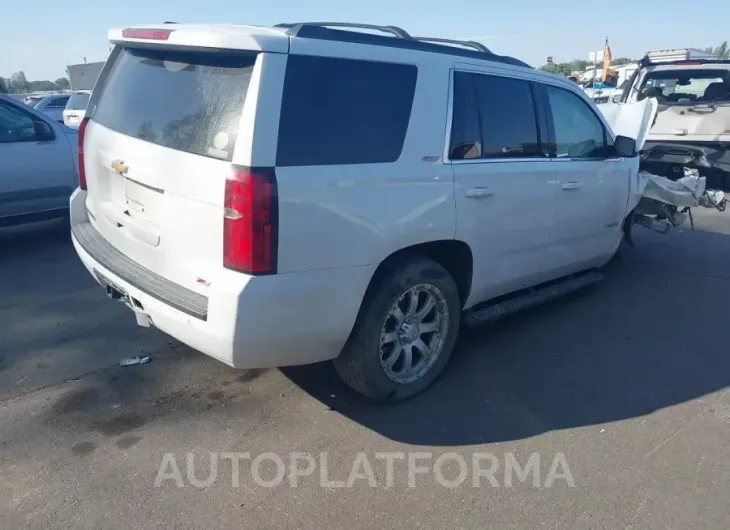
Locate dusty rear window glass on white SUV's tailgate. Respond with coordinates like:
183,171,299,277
92,48,256,161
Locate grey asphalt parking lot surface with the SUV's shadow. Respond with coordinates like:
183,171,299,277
0,212,730,529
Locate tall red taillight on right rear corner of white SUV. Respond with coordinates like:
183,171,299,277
223,168,278,274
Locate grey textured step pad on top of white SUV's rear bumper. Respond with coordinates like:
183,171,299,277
71,223,208,320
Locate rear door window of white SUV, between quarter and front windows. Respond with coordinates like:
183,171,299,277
450,72,544,160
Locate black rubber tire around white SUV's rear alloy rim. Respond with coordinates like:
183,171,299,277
334,257,461,402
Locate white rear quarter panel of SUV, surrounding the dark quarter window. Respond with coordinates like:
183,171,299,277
253,44,456,273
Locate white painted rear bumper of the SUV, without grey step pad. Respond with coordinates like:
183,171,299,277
71,190,374,368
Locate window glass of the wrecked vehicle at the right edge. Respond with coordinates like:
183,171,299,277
638,69,730,105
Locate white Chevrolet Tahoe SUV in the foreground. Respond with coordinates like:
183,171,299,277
71,23,638,401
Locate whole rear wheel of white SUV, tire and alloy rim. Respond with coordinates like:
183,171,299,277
334,258,461,401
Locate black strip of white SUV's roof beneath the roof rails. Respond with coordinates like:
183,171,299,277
278,23,532,68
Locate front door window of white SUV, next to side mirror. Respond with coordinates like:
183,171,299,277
545,86,607,158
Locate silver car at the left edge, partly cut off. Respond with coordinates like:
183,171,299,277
0,94,78,226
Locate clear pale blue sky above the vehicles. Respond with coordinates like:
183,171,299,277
0,0,730,81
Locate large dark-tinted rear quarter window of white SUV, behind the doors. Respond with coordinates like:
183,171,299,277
276,55,418,166
